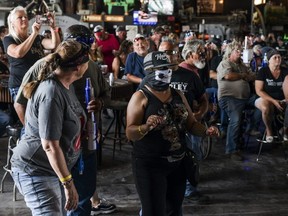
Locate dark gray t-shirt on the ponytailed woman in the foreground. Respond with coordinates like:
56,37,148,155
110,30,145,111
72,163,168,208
11,78,86,175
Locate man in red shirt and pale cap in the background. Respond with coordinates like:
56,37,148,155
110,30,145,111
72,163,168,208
92,25,119,72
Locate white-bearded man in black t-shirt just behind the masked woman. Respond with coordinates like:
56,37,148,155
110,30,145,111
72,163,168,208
169,40,209,202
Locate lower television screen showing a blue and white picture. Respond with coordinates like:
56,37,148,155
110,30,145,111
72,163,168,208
133,11,158,25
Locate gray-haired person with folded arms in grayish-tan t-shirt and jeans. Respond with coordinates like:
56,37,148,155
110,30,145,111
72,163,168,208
217,41,255,160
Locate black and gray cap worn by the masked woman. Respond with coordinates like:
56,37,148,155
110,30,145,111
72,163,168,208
144,51,176,71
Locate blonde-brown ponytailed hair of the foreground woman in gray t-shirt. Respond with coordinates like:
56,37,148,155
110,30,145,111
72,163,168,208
23,40,83,99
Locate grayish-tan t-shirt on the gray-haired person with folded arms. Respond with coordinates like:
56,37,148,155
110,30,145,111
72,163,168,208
217,60,250,99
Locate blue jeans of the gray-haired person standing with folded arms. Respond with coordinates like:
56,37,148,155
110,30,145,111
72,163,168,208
219,96,256,154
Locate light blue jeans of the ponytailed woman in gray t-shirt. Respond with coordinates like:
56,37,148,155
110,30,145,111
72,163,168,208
12,167,66,216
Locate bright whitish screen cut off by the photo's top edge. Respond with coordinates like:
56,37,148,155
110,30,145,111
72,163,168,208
148,0,174,15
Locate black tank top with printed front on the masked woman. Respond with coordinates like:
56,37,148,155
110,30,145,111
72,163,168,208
134,86,188,158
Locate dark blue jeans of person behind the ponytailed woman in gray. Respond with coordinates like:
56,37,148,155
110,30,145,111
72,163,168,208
67,152,97,216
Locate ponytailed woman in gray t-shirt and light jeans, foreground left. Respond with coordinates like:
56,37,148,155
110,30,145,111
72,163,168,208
11,40,89,215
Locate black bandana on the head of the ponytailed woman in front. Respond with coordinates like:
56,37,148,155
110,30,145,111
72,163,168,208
59,44,89,67
